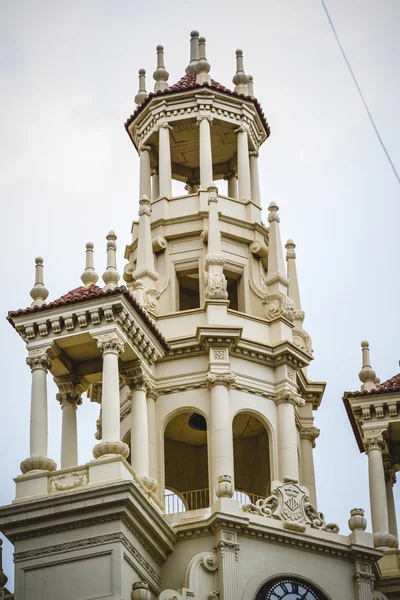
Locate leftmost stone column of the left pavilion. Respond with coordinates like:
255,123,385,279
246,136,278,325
20,346,57,473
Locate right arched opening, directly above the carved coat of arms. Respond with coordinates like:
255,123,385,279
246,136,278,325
232,411,271,505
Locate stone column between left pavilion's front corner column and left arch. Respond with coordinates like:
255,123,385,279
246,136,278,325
124,361,157,491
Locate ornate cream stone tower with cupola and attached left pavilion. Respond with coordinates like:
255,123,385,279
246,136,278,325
0,31,397,600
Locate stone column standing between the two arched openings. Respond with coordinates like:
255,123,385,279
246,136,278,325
207,372,235,502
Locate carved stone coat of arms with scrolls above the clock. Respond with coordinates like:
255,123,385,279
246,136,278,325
243,477,339,533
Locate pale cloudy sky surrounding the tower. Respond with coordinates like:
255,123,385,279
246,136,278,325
0,0,400,589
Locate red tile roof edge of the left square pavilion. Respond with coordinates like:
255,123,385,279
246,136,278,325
7,284,169,352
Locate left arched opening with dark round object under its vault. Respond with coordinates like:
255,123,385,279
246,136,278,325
164,410,210,514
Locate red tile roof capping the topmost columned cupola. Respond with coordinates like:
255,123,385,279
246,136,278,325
125,75,271,138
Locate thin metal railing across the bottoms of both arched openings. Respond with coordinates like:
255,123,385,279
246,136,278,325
164,488,264,515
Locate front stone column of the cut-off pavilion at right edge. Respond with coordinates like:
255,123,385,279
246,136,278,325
363,429,397,548
